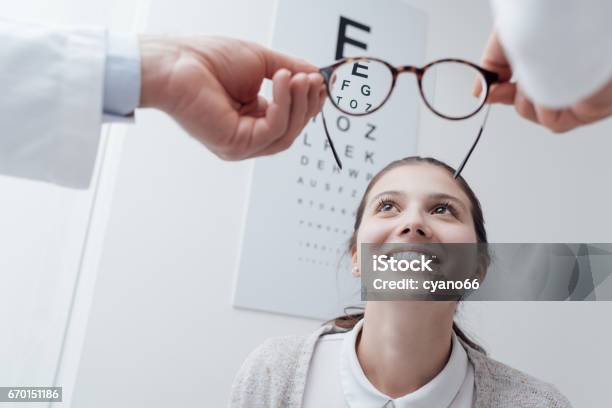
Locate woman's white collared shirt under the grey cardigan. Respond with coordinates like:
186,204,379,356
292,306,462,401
303,319,474,408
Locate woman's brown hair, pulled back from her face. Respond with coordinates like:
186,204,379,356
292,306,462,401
328,156,490,353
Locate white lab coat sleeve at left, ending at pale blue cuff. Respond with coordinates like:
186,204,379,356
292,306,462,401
0,20,106,188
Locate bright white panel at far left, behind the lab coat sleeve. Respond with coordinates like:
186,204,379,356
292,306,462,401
0,0,134,408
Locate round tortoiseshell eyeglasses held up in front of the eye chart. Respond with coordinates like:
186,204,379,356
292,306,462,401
319,57,499,178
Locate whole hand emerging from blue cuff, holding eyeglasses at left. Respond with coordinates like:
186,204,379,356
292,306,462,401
140,36,325,160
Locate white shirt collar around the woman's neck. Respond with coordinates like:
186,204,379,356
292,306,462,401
340,319,468,408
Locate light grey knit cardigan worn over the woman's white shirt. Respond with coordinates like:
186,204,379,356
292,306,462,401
230,325,571,408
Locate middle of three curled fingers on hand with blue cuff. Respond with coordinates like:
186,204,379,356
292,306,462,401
251,73,308,157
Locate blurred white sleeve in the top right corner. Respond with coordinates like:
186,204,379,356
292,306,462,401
491,0,612,107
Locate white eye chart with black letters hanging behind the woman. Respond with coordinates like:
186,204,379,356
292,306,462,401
234,0,426,319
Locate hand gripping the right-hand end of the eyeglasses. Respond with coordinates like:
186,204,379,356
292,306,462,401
474,32,612,133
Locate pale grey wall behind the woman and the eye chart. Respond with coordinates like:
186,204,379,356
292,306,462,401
73,0,612,408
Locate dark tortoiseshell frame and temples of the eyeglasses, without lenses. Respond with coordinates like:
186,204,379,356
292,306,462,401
319,56,499,171
